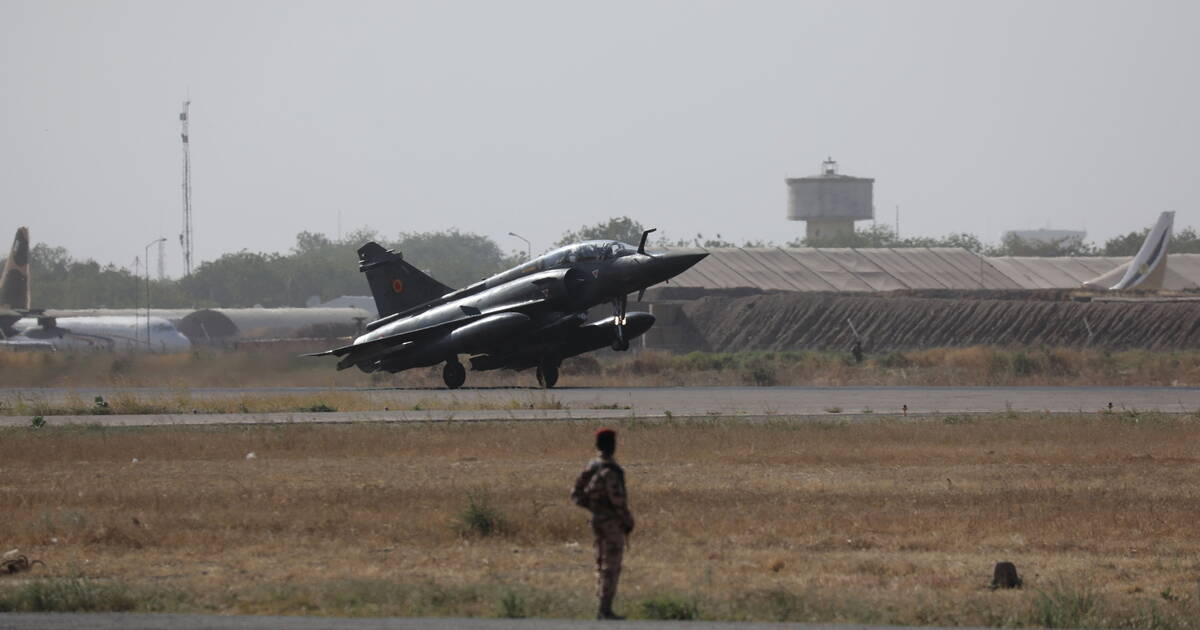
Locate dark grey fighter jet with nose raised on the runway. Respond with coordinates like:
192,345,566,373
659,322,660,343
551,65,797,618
306,229,708,389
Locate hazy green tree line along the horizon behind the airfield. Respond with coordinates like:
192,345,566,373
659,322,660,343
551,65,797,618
0,216,1200,308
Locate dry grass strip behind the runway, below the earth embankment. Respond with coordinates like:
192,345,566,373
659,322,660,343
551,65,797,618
0,346,1200,390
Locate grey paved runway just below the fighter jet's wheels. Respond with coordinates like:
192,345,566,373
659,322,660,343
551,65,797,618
0,388,1200,426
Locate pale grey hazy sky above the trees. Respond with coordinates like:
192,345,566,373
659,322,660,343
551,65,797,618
0,0,1200,275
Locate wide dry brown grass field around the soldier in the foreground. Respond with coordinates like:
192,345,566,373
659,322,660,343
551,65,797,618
0,414,1200,629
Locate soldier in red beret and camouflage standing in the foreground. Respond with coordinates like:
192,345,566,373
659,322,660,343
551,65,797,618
571,428,634,619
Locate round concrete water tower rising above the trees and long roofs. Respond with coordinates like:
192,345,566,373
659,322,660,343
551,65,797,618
787,157,875,240
